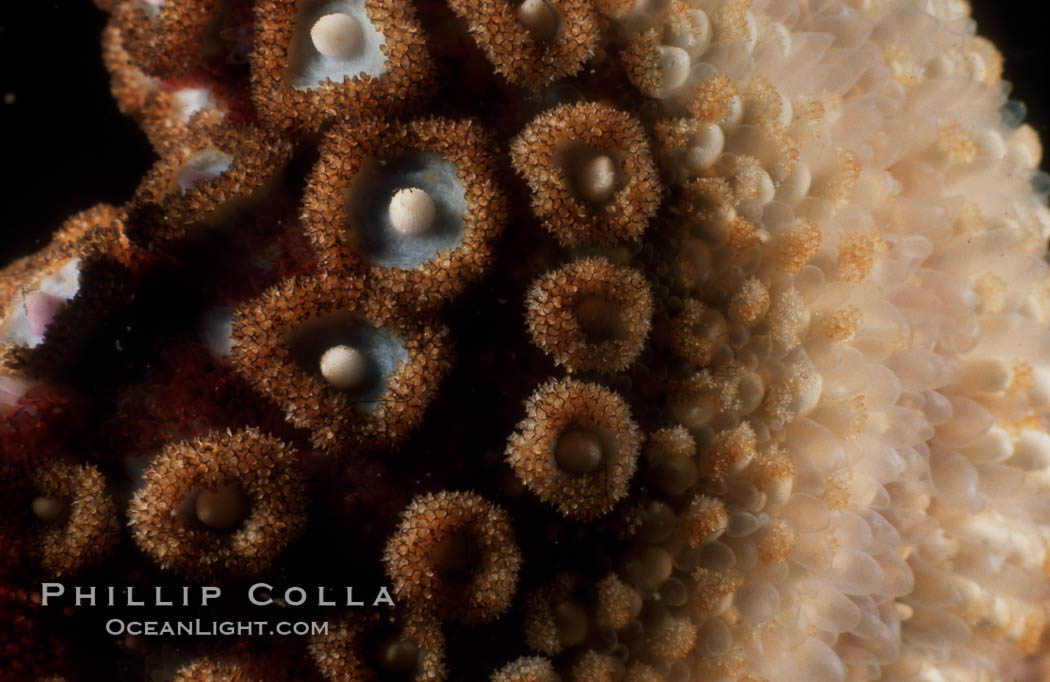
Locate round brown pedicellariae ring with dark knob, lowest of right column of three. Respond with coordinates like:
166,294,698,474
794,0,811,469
507,379,642,520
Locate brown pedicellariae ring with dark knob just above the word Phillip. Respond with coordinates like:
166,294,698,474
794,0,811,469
128,429,307,580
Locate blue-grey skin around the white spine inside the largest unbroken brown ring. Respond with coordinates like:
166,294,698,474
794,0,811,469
347,152,466,270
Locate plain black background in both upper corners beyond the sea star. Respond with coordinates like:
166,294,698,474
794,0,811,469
0,0,1050,265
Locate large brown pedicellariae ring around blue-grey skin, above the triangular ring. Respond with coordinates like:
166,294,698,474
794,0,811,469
302,119,507,310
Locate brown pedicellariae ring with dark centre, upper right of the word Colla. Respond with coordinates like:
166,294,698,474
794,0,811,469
383,491,521,623
